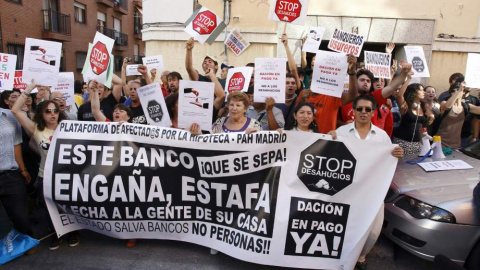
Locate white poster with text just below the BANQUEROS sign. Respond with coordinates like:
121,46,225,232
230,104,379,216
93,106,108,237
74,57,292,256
310,51,348,97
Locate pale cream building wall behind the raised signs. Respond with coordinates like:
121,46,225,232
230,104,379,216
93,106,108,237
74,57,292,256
143,0,480,91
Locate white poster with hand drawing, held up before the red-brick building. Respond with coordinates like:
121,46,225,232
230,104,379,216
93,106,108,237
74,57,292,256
23,38,62,86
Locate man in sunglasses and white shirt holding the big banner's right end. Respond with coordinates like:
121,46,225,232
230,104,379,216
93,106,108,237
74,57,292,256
328,95,404,270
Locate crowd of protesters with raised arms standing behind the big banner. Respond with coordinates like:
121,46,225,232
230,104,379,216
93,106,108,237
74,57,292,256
0,34,480,269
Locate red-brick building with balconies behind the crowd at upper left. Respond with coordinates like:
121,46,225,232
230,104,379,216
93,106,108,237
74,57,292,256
0,0,145,80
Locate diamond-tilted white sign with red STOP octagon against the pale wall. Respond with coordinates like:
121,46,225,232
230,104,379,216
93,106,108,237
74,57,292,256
184,7,227,45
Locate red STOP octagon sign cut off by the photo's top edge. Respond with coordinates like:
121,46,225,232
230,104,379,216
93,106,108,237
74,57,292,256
268,0,310,25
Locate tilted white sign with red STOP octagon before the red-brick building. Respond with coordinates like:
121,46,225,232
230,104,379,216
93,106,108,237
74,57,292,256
82,32,115,87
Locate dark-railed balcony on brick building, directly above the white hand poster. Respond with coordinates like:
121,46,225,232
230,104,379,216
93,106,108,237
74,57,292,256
42,9,72,41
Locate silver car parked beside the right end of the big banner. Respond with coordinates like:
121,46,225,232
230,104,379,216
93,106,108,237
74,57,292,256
382,143,480,270
